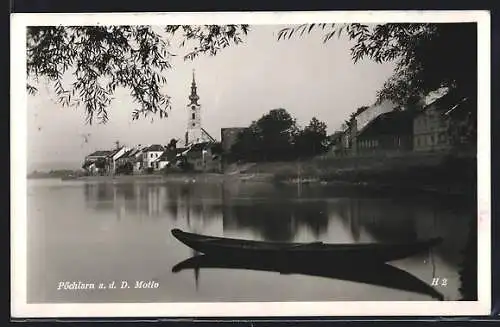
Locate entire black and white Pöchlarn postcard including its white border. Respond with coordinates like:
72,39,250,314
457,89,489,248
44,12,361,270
11,11,491,317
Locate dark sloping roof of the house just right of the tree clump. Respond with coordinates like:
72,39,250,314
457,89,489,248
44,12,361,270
358,110,414,137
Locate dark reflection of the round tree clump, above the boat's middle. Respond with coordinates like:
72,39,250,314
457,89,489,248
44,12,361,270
224,199,328,241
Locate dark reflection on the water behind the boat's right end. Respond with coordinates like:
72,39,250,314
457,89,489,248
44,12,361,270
337,197,474,265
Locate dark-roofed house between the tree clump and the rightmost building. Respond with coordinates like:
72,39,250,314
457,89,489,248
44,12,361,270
356,110,413,155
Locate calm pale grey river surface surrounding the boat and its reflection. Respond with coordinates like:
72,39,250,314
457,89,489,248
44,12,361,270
27,179,476,303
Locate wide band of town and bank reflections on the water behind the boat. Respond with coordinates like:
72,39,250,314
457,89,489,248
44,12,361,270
84,182,477,302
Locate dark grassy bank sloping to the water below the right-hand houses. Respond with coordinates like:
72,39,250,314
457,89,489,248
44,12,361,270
243,154,477,194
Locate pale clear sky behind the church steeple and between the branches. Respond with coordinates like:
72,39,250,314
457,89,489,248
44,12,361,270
27,25,394,171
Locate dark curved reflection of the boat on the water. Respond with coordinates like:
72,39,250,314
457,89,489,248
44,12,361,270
172,255,444,301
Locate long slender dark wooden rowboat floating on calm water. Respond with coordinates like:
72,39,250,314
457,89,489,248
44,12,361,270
172,229,442,263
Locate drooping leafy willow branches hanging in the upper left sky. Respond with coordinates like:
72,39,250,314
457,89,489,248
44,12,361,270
26,25,248,124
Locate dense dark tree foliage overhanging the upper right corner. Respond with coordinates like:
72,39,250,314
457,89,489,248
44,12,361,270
278,23,477,146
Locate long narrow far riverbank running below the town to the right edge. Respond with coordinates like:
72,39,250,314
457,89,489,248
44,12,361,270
47,154,477,194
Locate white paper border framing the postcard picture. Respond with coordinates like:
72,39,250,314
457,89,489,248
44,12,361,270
10,11,491,318
